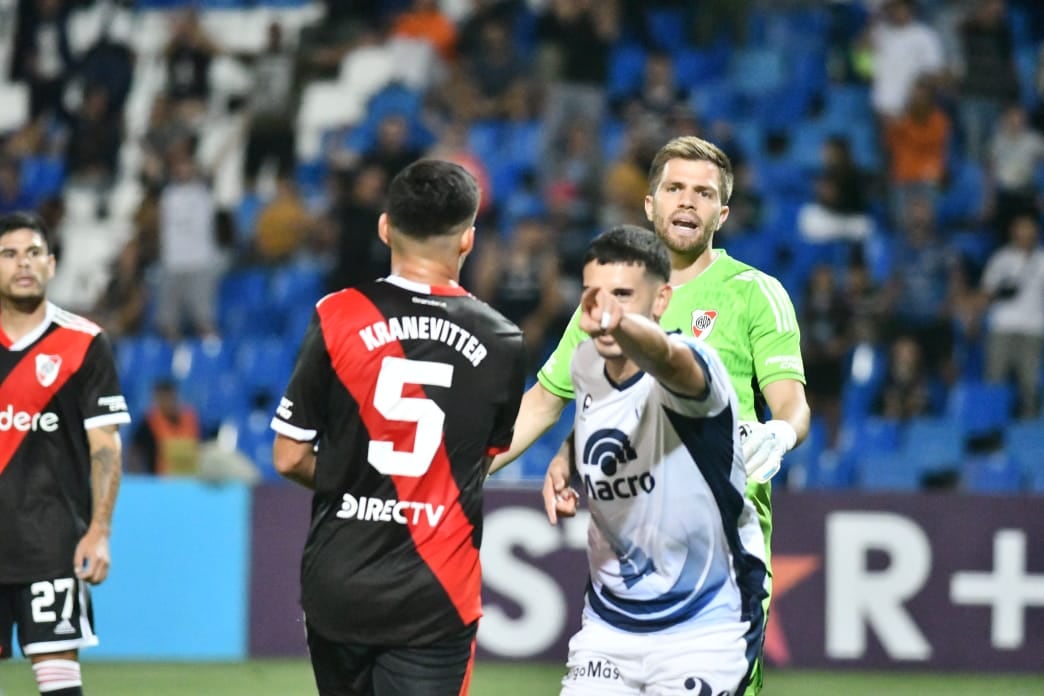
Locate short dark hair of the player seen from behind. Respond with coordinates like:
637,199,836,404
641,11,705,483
387,160,479,239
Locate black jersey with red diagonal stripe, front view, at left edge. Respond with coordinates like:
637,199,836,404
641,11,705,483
0,303,131,583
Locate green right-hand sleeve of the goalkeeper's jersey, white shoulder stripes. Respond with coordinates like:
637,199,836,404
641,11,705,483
749,273,805,389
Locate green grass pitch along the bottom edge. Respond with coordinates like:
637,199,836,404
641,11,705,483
0,659,1044,696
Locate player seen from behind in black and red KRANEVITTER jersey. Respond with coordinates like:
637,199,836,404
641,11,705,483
271,160,525,696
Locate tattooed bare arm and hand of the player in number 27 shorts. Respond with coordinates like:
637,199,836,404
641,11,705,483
73,426,121,584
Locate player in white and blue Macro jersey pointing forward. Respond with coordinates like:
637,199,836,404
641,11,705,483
562,225,766,696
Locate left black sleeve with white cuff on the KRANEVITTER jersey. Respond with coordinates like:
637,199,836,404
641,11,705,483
271,314,335,442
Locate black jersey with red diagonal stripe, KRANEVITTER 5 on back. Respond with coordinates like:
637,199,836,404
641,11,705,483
272,277,525,645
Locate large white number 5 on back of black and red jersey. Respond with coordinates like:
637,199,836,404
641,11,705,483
366,357,453,476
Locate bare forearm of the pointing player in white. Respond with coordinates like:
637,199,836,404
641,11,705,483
613,314,707,395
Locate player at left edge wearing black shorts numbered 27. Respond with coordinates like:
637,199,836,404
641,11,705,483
0,213,131,696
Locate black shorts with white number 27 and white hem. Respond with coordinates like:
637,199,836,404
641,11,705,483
0,577,98,658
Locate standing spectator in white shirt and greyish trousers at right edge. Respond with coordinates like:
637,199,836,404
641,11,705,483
982,215,1044,418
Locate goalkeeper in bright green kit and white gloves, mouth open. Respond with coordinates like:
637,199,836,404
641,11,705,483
491,136,811,694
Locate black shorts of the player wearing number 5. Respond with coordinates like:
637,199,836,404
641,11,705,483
307,622,478,696
